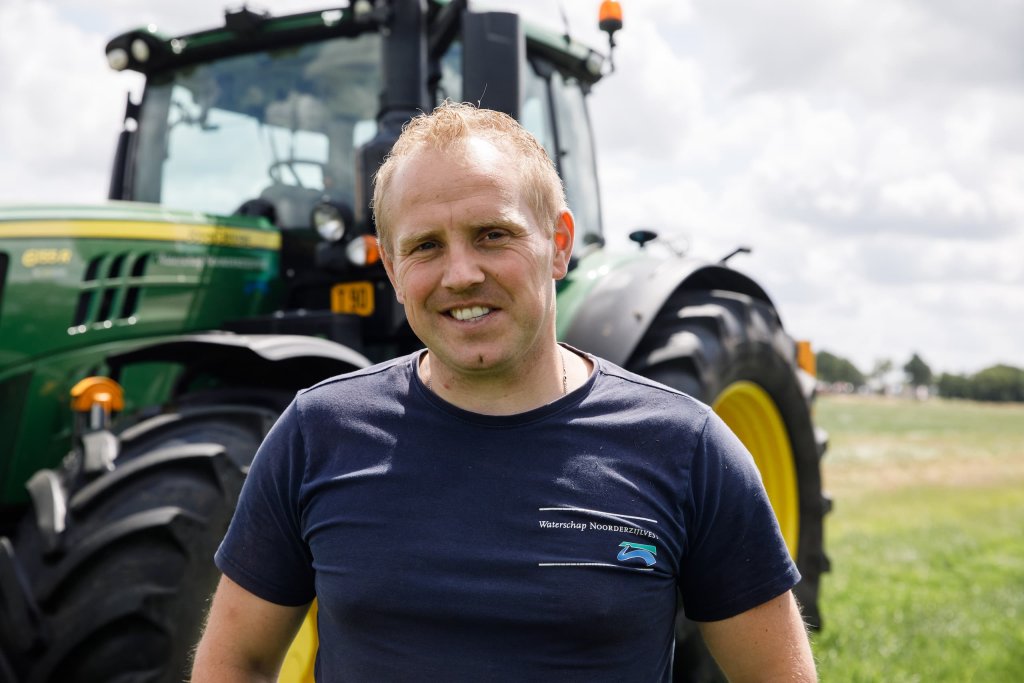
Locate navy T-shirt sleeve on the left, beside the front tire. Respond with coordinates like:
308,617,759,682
214,402,315,606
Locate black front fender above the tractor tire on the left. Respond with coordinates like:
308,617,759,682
108,332,372,390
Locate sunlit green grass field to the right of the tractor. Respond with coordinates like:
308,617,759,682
814,396,1024,683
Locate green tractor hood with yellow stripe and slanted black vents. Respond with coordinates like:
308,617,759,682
0,202,282,379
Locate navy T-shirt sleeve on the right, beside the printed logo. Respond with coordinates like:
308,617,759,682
679,412,800,622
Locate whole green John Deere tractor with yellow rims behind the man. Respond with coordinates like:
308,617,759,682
0,0,827,682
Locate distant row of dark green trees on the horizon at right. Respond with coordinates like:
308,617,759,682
817,351,1024,402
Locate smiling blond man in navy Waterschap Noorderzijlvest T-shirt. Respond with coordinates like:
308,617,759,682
194,104,814,682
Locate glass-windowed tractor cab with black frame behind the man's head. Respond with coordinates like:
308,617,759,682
106,0,603,327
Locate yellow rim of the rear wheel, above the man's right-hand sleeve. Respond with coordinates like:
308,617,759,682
712,382,800,558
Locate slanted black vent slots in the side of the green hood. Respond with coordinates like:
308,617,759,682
71,252,150,328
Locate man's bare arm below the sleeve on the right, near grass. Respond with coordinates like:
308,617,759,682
698,591,817,683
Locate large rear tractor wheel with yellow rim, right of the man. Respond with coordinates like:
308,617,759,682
629,291,828,683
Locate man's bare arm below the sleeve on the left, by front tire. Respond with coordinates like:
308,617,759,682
191,577,309,683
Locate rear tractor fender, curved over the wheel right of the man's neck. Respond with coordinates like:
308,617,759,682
562,252,774,367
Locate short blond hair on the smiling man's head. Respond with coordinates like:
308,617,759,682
373,100,568,254
